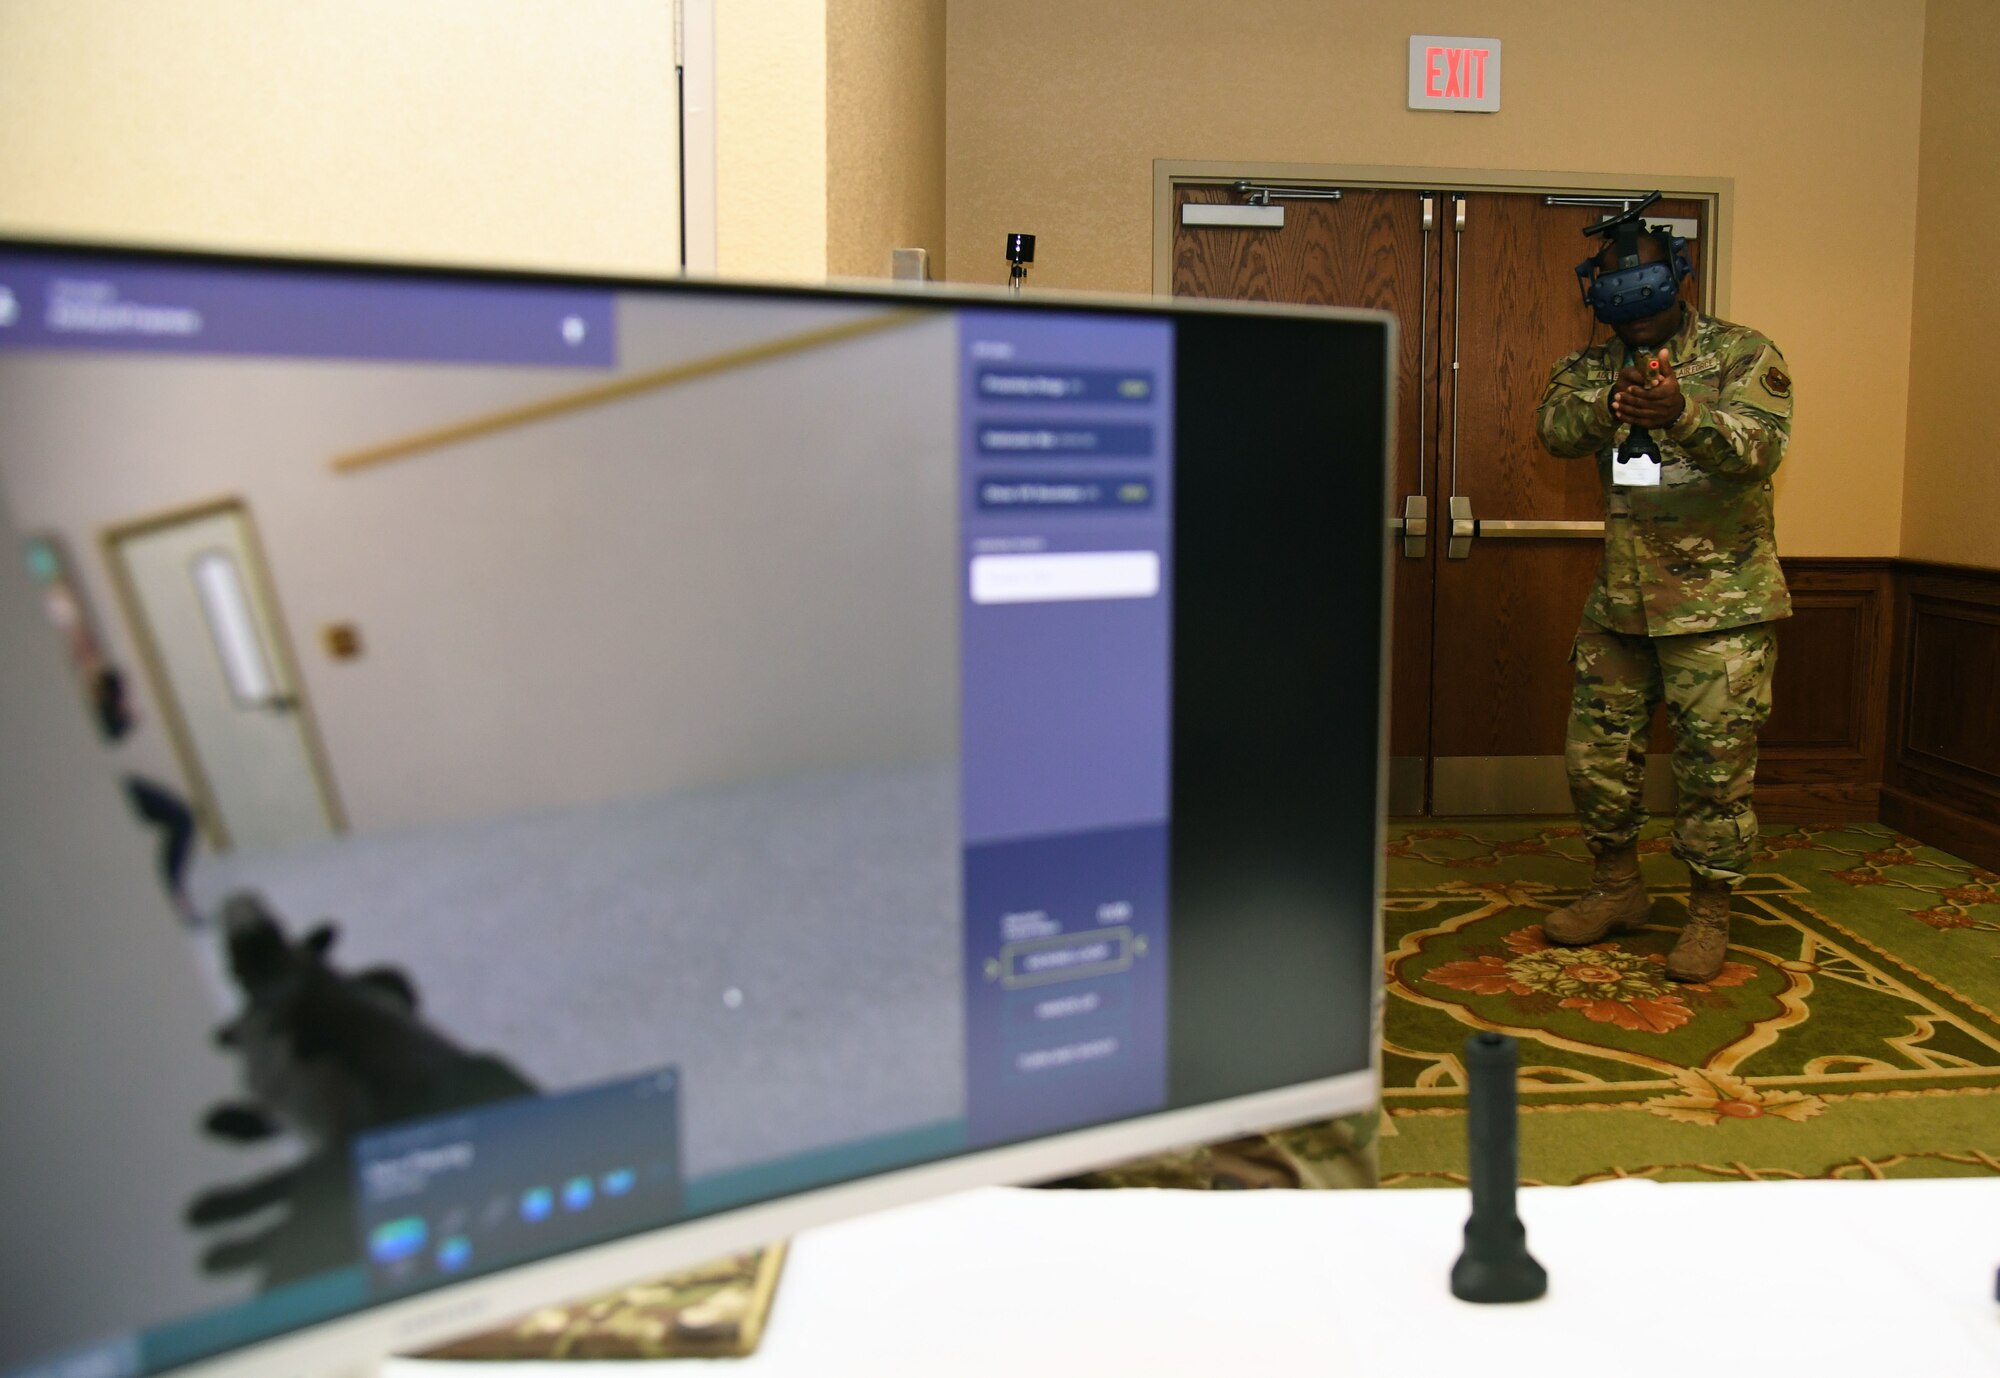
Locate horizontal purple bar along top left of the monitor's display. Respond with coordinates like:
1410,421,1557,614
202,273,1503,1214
0,254,616,368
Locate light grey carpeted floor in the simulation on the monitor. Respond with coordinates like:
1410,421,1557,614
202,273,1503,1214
190,762,964,1176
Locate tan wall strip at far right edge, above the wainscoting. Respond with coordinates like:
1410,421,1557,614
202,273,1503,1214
1902,0,2000,568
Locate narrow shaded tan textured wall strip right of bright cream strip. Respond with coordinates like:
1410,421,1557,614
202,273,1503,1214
826,0,944,278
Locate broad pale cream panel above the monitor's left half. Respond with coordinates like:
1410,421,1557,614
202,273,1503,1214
0,0,680,272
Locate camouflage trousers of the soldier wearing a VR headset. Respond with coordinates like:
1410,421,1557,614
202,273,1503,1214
1566,622,1778,884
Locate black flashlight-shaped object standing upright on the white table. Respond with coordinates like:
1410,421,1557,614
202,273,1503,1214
1452,1034,1548,1302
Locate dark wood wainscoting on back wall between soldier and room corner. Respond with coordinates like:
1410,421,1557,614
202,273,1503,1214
1756,560,1896,822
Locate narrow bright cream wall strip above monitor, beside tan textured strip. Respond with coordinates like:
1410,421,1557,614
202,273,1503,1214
716,0,826,282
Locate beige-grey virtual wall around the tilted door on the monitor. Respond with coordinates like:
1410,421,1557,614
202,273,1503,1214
0,298,958,830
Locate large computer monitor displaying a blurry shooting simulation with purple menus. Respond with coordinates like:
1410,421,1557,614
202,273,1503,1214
0,242,1394,1378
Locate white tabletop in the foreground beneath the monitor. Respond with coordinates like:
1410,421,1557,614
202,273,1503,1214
382,1180,2000,1378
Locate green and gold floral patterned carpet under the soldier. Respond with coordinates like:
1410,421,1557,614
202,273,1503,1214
1056,820,2000,1186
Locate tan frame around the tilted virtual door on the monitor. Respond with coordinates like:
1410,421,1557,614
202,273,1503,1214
98,494,348,852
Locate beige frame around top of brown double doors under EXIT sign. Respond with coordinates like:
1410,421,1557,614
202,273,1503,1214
1152,158,1736,316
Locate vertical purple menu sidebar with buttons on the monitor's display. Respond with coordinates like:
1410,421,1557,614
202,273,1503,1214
958,312,1174,1144
